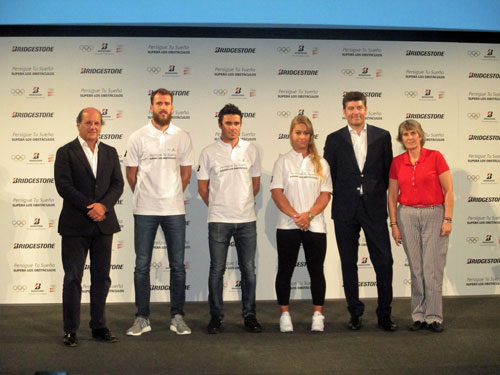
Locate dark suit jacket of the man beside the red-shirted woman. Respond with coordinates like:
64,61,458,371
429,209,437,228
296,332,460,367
324,125,392,220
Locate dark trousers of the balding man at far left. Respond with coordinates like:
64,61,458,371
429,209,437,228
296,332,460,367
62,226,113,332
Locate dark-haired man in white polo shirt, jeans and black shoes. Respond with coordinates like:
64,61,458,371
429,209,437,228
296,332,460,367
198,104,262,334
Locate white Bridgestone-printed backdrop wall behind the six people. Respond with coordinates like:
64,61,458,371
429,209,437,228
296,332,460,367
0,37,500,303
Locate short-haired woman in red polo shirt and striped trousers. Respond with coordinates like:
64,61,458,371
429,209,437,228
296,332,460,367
388,120,453,332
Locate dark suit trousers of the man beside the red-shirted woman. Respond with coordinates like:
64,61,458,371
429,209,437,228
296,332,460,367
334,203,393,318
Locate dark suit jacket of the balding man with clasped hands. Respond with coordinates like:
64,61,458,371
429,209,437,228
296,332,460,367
54,138,123,236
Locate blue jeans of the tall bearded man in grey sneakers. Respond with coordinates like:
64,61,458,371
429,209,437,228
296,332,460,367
134,215,186,318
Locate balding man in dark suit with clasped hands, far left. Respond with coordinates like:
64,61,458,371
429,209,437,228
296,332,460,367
54,108,123,346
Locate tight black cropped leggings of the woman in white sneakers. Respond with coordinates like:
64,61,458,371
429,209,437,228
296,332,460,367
276,229,326,306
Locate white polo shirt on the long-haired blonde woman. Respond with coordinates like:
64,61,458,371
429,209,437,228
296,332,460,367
270,149,332,233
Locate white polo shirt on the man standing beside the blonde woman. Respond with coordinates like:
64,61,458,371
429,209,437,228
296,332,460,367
198,138,260,223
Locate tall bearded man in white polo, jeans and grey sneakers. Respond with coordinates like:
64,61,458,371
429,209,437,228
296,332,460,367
124,88,194,336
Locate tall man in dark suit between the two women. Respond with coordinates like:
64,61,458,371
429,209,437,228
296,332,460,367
324,91,397,331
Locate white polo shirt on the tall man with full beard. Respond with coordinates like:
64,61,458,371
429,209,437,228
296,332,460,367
123,121,194,216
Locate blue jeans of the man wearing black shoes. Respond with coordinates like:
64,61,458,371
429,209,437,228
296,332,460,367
208,221,257,318
